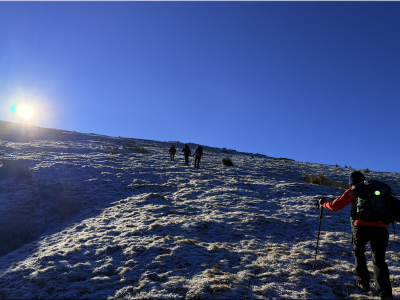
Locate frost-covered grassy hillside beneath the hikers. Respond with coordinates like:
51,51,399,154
0,121,400,299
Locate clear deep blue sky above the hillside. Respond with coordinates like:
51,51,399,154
0,2,400,172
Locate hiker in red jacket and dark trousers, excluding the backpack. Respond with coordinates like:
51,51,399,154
317,171,393,300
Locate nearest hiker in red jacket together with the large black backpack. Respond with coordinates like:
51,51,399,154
316,171,400,300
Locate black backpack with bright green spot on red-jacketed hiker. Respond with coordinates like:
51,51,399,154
350,180,400,225
